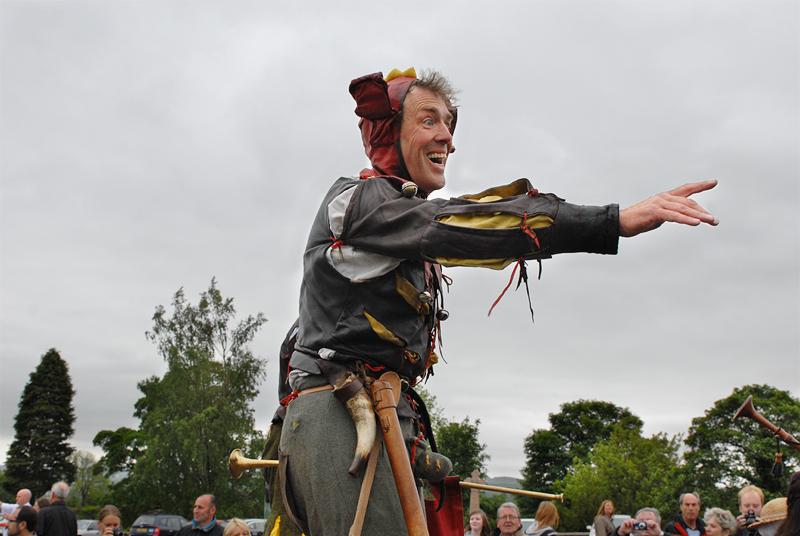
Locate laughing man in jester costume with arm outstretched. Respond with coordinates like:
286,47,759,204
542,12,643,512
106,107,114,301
264,69,717,536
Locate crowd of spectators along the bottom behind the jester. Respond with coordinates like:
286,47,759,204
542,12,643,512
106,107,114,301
0,472,800,536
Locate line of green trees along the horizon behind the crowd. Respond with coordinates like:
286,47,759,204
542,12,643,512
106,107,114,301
0,279,800,530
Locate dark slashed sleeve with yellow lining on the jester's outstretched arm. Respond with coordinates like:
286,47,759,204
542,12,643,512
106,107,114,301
341,178,619,268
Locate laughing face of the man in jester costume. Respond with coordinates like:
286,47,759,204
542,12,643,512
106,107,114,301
400,87,453,193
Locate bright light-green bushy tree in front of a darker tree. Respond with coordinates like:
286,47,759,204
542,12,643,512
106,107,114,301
561,426,681,531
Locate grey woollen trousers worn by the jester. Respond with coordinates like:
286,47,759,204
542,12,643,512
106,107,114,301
280,391,408,536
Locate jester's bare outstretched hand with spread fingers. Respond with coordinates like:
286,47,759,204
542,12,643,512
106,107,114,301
619,179,719,237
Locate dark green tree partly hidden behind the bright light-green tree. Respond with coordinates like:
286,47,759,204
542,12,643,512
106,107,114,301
517,400,642,517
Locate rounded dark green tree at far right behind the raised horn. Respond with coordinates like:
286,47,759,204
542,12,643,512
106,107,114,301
684,385,800,508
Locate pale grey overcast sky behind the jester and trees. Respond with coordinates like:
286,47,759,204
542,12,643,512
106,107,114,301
0,0,800,476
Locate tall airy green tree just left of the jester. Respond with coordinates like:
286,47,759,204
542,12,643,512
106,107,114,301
95,279,265,517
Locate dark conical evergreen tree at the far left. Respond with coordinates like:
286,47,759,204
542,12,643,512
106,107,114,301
4,348,75,495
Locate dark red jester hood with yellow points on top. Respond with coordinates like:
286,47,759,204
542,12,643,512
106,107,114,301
350,67,456,186
